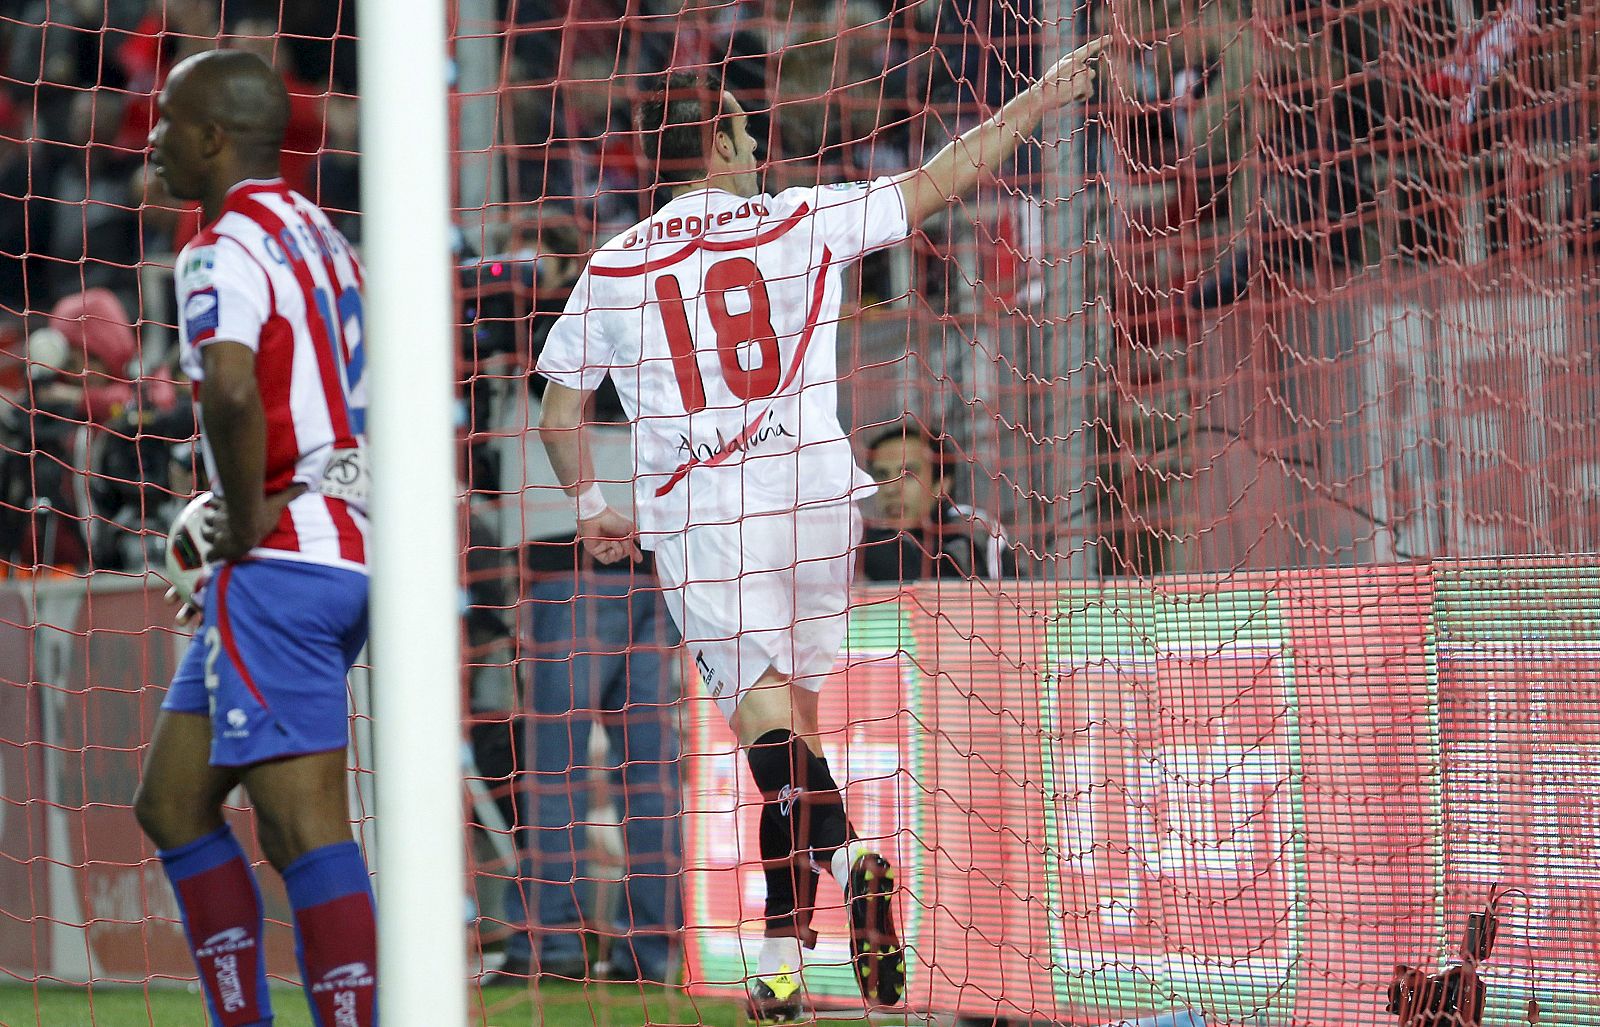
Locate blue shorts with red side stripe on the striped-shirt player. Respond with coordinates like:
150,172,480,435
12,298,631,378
162,560,366,766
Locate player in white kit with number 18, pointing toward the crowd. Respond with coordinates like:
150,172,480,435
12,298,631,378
538,40,1104,1024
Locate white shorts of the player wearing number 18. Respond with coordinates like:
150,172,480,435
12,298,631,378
656,502,861,720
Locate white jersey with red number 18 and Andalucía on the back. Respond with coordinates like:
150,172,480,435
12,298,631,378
538,178,910,547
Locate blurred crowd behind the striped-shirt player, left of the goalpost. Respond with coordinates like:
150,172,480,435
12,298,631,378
0,0,358,574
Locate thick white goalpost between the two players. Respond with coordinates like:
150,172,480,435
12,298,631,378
358,0,466,1027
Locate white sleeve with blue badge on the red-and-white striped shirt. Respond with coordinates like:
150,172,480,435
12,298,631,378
174,238,272,363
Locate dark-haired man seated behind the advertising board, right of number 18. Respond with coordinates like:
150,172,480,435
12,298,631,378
858,422,1016,582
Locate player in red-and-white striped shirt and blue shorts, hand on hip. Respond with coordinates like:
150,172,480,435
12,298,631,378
134,50,378,1027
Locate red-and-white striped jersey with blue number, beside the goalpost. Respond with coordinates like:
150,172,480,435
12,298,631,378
176,179,366,571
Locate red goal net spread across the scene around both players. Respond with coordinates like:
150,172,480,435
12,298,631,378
0,0,1600,1027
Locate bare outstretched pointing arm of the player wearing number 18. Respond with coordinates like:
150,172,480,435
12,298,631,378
894,35,1110,229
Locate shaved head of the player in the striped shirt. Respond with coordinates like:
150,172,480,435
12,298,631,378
150,50,290,202
